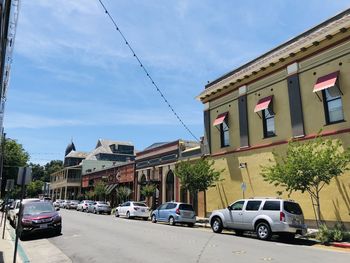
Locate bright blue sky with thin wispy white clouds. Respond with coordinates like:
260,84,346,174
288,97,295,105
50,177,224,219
4,0,350,164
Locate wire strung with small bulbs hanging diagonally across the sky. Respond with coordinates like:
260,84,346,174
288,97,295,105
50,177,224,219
98,0,199,141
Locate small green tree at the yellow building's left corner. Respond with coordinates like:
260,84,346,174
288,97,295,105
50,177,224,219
175,158,224,210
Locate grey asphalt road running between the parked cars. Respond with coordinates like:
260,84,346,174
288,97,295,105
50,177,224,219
44,210,350,263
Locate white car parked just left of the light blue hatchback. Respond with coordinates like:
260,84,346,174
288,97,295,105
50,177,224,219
115,201,150,220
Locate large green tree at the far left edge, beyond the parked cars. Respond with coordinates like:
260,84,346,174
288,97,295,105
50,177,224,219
1,138,29,198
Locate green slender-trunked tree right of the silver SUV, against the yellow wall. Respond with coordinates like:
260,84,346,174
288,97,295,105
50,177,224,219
261,136,350,226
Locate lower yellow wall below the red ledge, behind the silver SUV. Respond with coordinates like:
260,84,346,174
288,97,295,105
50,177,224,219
207,133,350,226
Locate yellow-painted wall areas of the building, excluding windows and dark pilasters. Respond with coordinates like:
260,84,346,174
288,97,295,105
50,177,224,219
207,37,350,227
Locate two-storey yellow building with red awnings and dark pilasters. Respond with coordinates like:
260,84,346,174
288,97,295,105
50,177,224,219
198,9,350,228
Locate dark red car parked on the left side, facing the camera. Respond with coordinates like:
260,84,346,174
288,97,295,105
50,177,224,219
19,201,62,238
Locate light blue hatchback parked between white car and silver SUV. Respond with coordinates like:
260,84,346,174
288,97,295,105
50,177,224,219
151,202,196,227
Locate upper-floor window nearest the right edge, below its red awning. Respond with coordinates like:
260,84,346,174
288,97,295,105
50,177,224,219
322,86,344,124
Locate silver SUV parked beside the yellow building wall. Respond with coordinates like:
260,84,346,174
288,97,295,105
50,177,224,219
209,198,307,240
